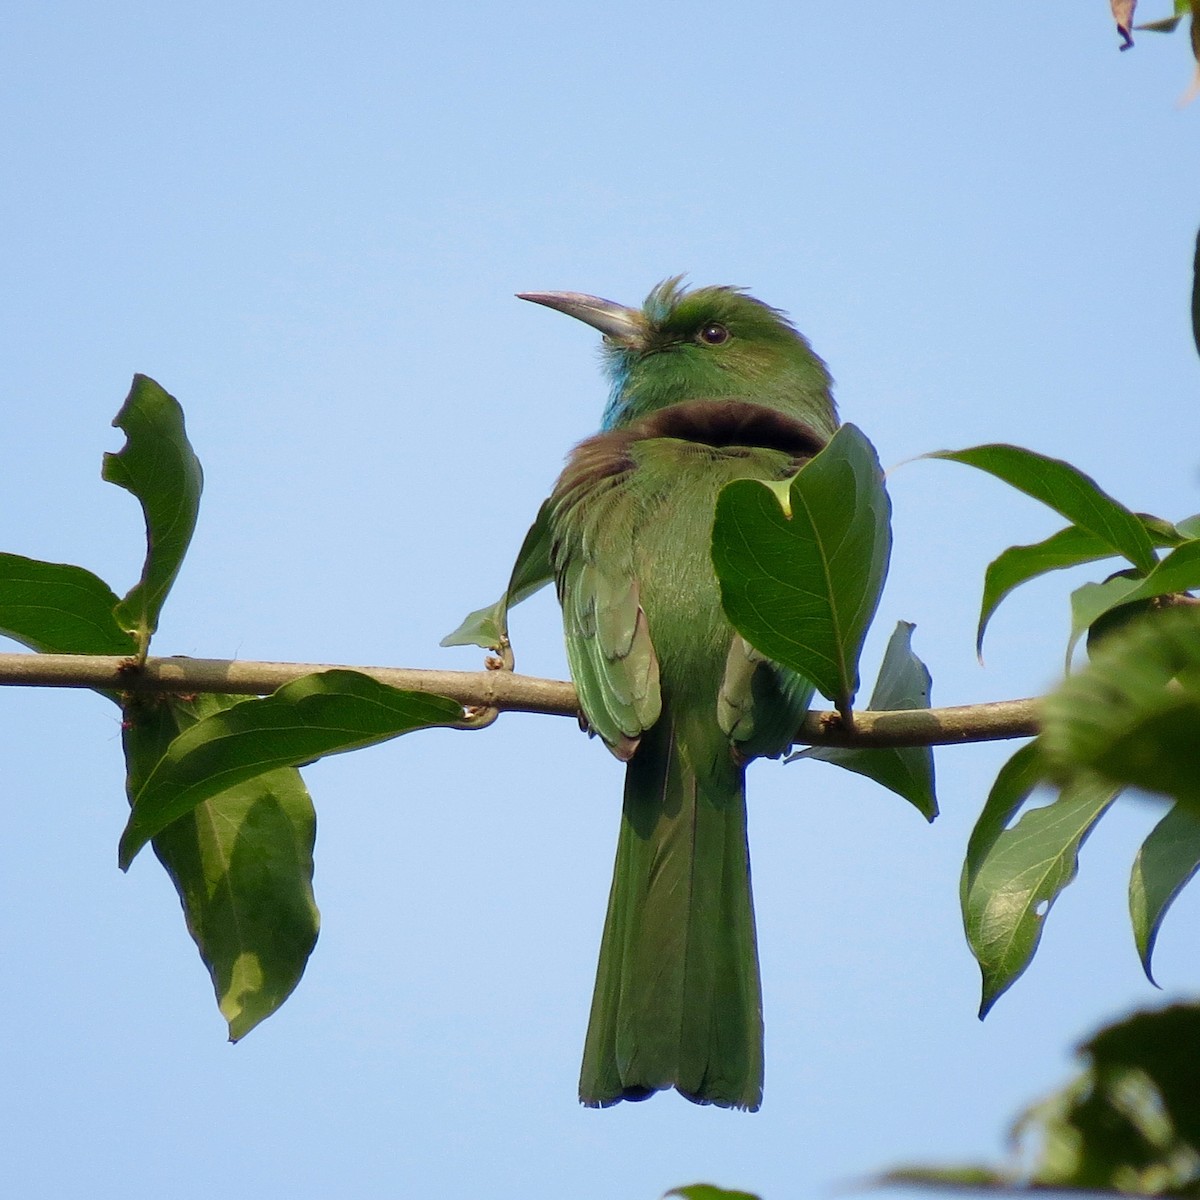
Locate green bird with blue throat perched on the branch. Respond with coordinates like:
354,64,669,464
520,277,838,1111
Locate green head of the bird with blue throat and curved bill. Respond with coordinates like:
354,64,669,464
521,278,838,436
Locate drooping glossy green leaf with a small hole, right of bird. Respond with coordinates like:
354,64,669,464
962,746,1120,1018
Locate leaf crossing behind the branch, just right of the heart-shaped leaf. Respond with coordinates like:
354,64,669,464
786,620,937,821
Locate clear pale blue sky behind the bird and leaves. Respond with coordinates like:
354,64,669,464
0,7,1200,1200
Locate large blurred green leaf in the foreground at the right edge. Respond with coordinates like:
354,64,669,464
1040,606,1200,806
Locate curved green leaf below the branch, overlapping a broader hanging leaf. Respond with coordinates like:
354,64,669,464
120,671,462,870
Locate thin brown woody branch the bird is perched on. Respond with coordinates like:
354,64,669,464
0,654,1040,746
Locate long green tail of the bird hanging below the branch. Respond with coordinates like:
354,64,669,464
580,713,762,1110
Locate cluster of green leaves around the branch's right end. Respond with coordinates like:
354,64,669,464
932,446,1200,1013
